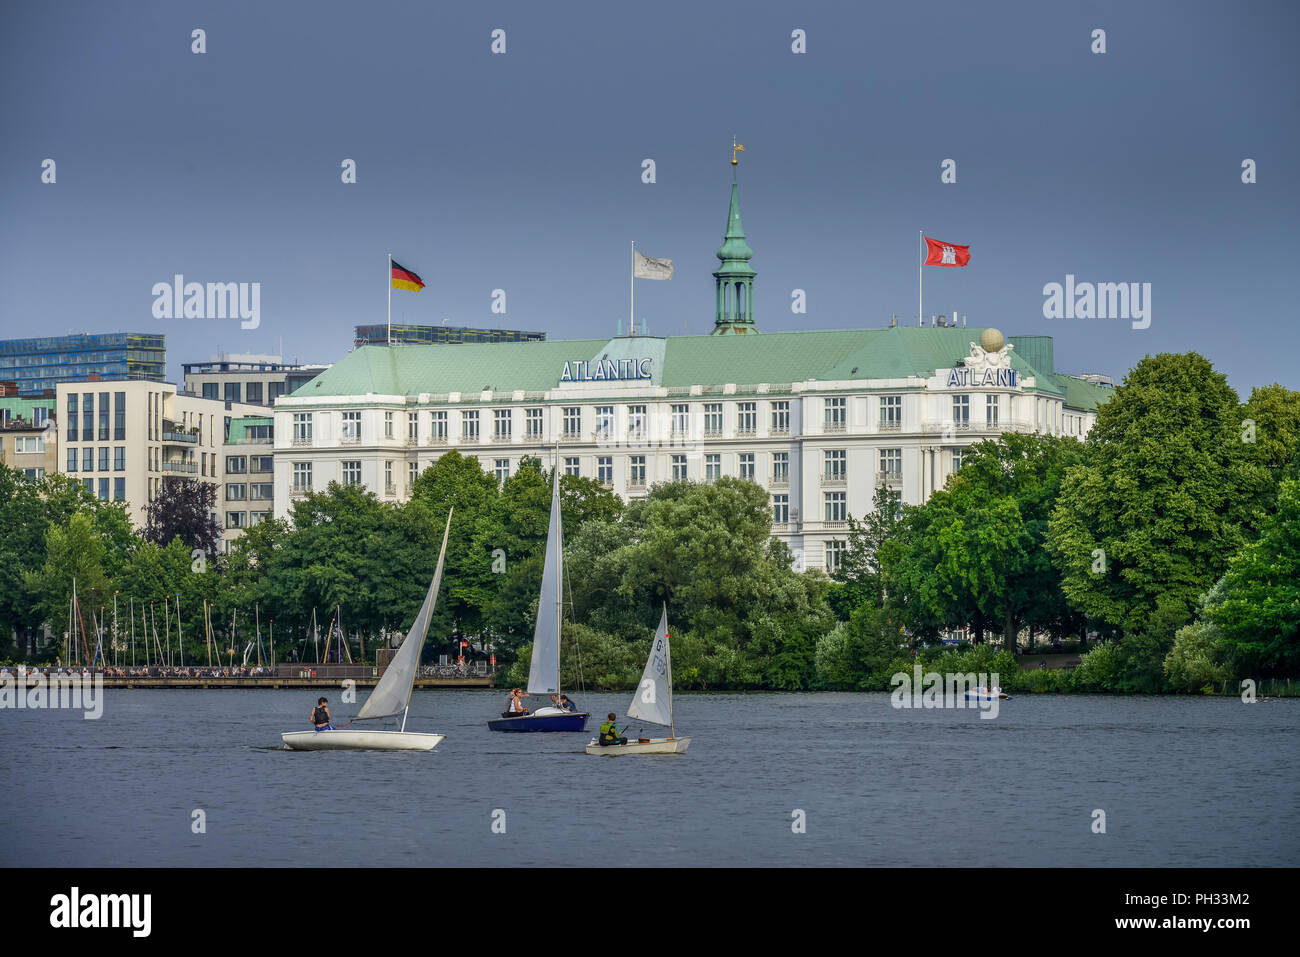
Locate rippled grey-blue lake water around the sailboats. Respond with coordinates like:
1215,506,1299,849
0,689,1300,866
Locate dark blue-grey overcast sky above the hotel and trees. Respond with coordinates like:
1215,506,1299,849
0,0,1300,398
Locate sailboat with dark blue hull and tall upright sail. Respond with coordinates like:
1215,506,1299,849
488,463,590,731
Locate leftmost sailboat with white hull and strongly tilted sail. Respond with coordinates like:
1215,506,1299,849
281,508,452,752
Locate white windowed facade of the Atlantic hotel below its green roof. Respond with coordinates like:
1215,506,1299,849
274,358,1096,568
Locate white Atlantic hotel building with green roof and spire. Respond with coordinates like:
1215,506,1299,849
273,186,1112,568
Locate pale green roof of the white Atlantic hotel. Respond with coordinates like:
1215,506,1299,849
292,326,1113,410
